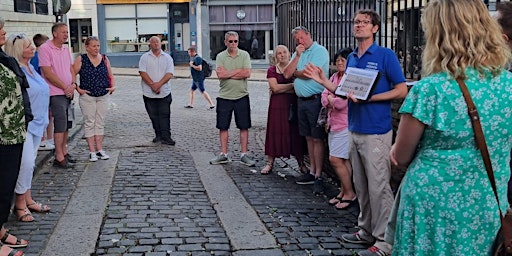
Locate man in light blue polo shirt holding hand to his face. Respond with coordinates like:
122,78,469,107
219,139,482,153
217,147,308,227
283,26,329,194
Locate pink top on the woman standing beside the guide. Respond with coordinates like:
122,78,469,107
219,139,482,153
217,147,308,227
322,72,348,132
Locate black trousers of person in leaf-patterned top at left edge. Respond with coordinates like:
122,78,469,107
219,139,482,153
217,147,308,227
0,143,23,226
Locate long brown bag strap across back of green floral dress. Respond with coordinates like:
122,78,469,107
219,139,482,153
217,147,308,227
457,78,503,217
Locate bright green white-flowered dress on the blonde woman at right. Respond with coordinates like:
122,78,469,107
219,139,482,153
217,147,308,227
393,68,512,256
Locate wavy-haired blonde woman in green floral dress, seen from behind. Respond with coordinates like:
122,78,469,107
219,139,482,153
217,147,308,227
390,0,512,256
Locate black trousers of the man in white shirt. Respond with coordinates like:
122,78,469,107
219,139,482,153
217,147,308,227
144,93,172,139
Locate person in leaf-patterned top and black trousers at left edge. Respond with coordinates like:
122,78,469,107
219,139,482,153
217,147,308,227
0,18,33,256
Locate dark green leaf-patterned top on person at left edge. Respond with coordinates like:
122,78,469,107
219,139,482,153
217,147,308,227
0,64,26,145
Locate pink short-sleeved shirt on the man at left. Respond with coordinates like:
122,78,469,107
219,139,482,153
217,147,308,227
38,40,73,96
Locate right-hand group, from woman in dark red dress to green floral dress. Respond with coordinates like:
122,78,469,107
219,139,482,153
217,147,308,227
261,0,512,256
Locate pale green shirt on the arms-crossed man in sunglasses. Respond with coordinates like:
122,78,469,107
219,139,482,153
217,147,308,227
216,49,251,100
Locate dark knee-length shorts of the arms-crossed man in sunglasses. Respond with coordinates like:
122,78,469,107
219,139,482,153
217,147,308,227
216,95,251,131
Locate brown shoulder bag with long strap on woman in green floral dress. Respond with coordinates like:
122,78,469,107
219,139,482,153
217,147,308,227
457,78,512,256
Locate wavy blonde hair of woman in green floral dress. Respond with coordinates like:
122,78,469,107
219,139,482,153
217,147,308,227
421,0,510,79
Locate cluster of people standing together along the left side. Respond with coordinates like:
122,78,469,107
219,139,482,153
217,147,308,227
0,20,114,256
